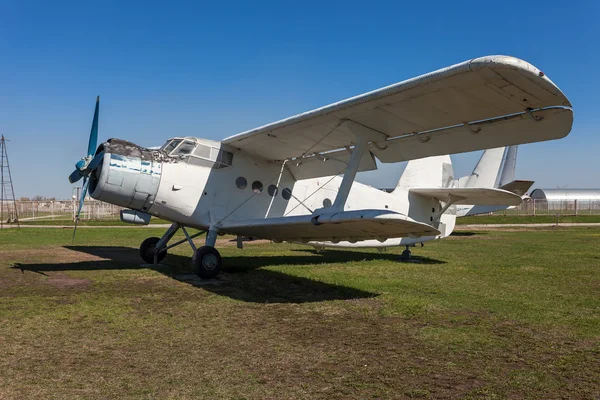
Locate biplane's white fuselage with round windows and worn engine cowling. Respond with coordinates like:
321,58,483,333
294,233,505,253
90,139,455,247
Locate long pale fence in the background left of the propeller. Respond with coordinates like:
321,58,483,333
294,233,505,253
3,200,123,222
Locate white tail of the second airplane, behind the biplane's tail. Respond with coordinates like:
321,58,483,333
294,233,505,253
454,146,534,218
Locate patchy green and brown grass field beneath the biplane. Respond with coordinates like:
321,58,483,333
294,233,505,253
0,227,600,399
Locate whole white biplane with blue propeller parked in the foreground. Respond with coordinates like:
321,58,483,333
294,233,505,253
69,56,573,278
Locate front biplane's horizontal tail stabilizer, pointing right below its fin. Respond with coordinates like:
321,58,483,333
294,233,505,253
410,188,522,206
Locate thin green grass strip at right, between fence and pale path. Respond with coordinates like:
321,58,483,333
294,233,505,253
456,215,600,225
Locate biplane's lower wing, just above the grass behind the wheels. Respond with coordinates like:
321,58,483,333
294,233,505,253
218,210,440,243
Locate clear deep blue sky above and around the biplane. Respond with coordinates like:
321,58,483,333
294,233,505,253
0,0,600,198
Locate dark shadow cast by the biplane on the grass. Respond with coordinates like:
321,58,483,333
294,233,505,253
12,246,436,303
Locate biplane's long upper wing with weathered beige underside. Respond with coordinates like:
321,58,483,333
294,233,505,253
223,56,573,162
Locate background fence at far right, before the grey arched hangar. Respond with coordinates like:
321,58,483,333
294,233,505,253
488,199,600,215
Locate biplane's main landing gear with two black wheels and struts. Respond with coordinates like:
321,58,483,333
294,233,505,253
140,223,223,279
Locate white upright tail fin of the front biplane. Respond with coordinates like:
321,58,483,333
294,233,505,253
393,155,454,194
